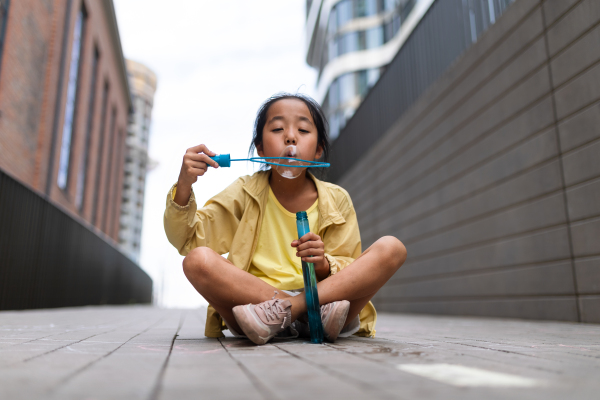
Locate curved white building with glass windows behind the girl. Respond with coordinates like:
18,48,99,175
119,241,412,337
306,0,511,139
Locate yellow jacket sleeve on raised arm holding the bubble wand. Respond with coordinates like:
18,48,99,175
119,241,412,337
164,179,245,256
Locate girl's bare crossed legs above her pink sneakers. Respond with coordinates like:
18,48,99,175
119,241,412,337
183,236,406,332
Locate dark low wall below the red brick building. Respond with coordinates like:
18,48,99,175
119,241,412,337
0,171,152,310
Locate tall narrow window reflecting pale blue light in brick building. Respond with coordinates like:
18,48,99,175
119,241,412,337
58,9,86,189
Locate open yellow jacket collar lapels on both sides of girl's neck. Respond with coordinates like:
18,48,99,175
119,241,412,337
243,171,346,231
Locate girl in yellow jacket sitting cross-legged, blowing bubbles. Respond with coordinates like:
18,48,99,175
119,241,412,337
164,94,406,344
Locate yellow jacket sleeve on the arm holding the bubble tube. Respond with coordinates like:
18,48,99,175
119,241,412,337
323,191,362,275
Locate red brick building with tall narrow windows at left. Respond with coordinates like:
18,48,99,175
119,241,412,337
0,0,132,241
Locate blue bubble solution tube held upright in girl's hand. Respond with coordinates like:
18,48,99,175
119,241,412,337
296,211,323,343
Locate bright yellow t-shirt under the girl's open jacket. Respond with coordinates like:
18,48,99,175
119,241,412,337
248,187,319,290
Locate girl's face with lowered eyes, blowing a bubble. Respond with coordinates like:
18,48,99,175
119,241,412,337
256,99,323,171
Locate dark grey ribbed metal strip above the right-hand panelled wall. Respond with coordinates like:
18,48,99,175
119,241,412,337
327,0,514,182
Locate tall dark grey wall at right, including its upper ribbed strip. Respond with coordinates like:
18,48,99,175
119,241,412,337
330,0,600,323
